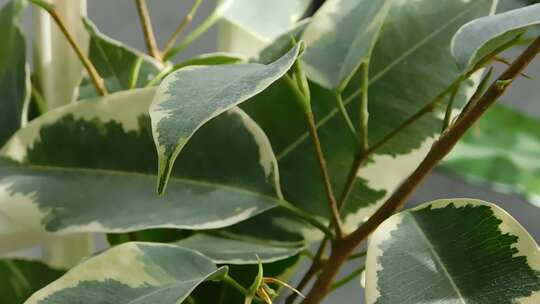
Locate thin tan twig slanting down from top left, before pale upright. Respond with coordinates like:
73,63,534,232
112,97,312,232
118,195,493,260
30,0,108,96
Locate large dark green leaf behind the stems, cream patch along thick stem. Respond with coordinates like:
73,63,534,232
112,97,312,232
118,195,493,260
240,0,492,238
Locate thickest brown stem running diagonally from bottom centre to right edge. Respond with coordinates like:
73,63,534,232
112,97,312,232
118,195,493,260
303,37,540,304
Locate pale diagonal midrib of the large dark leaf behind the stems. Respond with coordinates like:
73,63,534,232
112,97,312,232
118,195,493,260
276,0,487,161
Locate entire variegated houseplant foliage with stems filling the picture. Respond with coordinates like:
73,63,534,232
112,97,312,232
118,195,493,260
0,0,540,304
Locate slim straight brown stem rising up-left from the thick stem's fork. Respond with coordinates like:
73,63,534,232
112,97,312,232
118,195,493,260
306,111,343,239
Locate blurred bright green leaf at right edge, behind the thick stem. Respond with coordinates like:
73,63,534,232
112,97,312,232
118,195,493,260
443,105,540,207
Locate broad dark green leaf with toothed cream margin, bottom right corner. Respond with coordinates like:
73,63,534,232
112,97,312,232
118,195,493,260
366,199,540,304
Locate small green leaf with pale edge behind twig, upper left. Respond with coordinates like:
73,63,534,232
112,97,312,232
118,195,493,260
79,19,161,99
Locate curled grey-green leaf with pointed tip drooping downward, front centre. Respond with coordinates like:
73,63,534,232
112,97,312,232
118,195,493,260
150,44,302,194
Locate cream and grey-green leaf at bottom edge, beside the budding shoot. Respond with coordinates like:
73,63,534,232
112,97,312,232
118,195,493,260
24,243,227,304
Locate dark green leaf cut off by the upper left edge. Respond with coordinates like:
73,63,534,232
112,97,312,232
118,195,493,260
0,0,30,147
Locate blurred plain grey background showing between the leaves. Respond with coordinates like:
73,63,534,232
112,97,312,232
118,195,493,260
0,0,540,304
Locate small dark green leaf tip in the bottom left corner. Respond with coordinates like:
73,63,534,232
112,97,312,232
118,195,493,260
0,259,64,304
